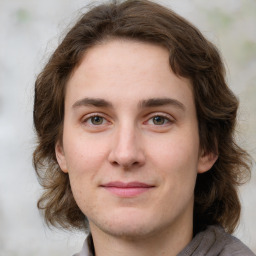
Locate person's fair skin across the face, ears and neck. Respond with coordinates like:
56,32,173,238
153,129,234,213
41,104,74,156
56,40,216,256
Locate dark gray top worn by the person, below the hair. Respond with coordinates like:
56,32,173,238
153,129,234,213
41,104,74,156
73,225,255,256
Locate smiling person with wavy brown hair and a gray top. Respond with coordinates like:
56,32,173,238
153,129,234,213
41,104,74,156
33,0,254,256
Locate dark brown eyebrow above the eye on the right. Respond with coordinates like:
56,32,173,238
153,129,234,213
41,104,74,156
140,98,186,111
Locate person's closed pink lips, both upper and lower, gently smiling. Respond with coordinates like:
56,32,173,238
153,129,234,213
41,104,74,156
101,181,154,197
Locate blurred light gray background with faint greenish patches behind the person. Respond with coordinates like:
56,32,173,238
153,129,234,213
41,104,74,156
0,0,256,256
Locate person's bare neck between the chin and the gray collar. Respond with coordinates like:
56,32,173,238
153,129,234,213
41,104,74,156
91,220,193,256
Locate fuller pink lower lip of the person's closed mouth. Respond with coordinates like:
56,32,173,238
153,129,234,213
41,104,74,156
104,187,153,197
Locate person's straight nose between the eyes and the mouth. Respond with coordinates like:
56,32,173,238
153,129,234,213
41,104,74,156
109,126,145,169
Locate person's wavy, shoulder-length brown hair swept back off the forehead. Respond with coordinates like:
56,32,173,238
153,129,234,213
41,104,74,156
33,0,250,233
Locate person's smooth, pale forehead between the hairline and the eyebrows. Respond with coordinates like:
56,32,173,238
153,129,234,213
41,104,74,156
66,40,193,108
